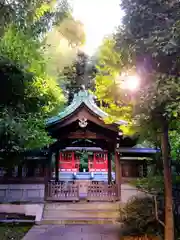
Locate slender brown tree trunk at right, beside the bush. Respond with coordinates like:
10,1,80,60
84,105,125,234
161,121,174,240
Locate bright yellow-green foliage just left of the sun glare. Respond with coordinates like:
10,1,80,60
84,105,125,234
95,37,135,134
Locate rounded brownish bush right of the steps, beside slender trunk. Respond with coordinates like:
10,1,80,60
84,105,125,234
119,197,163,239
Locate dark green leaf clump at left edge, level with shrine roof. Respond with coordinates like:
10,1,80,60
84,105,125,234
0,110,53,153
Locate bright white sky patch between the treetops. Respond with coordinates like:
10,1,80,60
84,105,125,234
71,0,123,55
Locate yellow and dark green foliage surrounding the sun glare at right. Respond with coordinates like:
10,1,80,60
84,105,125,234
96,0,180,156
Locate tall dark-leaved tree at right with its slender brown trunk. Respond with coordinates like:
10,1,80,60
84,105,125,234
94,0,180,239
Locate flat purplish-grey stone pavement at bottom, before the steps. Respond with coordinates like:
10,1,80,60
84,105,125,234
22,224,120,240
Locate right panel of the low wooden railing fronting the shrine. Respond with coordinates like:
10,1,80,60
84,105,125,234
87,182,118,201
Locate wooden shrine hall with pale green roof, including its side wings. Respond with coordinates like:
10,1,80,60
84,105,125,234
0,90,157,201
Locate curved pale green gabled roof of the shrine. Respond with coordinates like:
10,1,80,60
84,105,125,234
47,90,127,125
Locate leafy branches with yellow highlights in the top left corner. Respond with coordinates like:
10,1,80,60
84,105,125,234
0,0,70,38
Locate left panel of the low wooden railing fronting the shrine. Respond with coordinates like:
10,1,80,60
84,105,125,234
46,182,79,201
